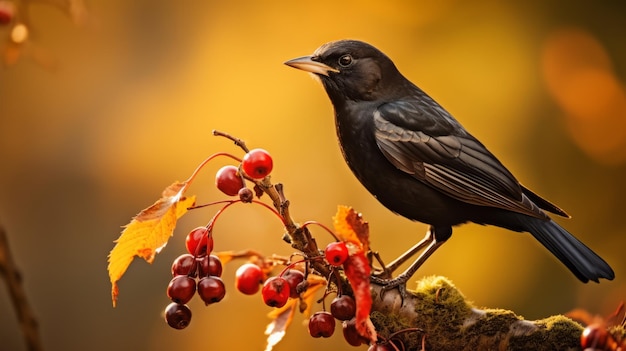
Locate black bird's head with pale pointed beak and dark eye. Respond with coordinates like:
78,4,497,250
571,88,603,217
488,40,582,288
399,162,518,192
285,40,406,105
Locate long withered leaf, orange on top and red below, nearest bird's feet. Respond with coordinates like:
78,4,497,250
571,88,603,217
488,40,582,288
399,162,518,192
333,206,377,343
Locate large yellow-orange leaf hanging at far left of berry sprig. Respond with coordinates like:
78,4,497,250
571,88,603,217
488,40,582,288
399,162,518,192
107,182,195,307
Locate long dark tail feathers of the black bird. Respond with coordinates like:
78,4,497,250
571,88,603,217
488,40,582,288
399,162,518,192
502,214,615,283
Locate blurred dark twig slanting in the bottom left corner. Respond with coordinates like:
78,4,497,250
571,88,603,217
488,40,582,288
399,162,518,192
0,224,43,351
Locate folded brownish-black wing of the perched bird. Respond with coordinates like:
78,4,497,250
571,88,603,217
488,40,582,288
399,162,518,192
374,100,546,218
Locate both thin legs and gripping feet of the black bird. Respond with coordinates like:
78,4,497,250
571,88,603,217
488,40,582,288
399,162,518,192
371,226,452,297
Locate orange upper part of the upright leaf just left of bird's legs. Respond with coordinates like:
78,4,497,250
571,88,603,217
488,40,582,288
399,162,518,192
333,206,369,252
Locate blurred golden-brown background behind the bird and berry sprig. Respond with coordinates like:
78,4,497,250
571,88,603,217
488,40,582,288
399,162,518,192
0,0,626,351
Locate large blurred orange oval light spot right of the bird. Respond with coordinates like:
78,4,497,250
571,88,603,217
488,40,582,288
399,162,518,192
542,28,626,164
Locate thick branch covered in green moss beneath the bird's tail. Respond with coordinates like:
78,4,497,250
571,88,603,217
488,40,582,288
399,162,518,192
371,276,583,351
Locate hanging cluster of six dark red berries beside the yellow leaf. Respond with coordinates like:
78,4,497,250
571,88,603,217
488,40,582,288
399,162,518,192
165,227,226,329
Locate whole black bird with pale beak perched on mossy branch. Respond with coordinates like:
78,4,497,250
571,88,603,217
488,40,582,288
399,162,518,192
285,40,615,288
